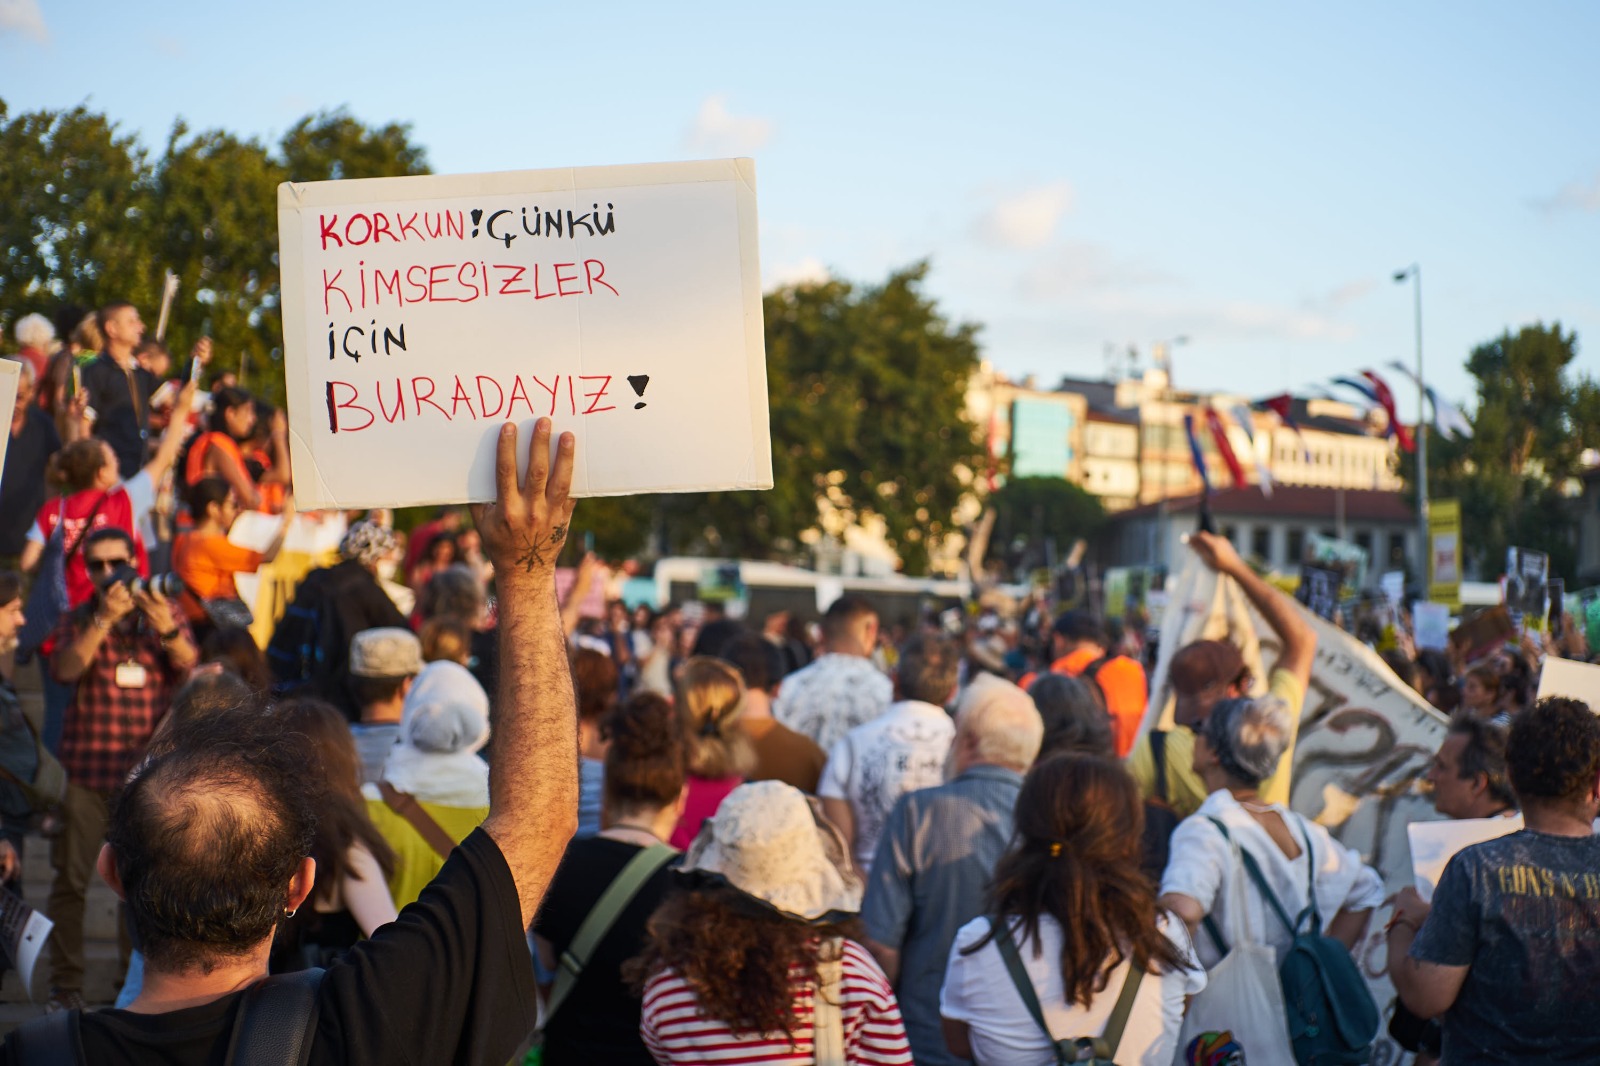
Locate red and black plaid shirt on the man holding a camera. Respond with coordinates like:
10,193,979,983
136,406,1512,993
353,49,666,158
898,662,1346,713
54,608,190,792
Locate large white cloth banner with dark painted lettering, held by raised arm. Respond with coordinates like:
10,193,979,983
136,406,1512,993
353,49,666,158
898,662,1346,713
1147,555,1450,1066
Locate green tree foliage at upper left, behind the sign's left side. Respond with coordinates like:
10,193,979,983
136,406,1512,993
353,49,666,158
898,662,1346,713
0,101,427,402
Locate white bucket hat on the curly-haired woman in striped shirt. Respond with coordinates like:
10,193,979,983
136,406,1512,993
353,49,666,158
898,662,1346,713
680,781,862,922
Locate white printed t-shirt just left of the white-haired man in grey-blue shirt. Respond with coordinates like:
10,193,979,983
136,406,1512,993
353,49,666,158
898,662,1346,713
816,699,955,872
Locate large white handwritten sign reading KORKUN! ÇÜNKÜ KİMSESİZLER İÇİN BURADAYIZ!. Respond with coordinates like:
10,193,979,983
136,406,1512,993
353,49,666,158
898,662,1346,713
278,158,773,511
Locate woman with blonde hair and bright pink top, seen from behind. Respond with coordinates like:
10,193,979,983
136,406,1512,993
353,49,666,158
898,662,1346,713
667,655,755,848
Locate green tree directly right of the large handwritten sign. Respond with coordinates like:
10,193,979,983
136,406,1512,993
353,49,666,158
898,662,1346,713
653,262,984,573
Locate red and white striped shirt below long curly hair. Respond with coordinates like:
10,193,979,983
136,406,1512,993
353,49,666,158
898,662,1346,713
638,940,912,1066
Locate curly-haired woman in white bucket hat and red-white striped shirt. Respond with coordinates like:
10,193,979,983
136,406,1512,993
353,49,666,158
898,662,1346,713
624,781,912,1066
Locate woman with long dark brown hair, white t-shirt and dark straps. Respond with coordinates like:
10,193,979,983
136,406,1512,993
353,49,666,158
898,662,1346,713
939,754,1205,1066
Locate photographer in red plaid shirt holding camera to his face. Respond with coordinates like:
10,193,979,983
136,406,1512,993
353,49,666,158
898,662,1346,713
48,527,198,1008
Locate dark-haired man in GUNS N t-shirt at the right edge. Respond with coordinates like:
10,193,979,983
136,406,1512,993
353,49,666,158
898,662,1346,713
1389,698,1600,1066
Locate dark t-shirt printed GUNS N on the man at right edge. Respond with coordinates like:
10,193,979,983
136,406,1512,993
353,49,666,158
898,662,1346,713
1411,829,1600,1066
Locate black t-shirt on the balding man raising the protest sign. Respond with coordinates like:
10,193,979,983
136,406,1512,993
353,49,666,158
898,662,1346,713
3,829,536,1066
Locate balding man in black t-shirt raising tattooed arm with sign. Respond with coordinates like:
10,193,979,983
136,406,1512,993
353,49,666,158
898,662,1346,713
0,419,578,1066
